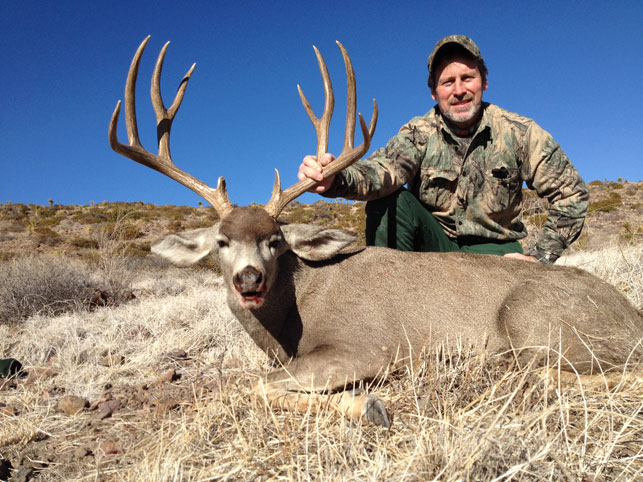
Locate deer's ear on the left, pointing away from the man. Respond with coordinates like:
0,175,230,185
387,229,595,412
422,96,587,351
152,223,219,267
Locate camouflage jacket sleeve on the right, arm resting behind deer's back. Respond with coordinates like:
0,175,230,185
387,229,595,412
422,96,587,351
522,123,589,264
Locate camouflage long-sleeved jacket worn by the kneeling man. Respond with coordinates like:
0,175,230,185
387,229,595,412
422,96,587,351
325,103,589,263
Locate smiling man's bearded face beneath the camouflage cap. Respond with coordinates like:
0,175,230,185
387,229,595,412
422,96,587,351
431,57,488,129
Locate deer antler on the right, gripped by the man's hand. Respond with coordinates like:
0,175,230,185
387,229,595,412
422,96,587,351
266,42,377,218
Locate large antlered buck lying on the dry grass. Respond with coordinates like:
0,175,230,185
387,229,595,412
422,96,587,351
109,36,643,427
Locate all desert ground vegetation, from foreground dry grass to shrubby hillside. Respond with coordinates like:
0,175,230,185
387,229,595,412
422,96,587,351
0,182,643,481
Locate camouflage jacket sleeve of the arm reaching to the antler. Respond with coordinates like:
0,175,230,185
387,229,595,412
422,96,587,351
323,120,427,201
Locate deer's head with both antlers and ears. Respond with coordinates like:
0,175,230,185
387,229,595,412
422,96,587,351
109,36,377,309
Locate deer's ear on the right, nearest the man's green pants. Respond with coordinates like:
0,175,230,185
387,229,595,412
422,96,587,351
281,224,357,261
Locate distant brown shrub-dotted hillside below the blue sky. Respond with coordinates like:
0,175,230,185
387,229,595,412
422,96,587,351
0,181,643,260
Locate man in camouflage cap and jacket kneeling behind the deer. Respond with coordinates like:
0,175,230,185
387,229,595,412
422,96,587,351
298,35,589,263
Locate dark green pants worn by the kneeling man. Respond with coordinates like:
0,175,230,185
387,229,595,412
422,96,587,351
366,189,522,256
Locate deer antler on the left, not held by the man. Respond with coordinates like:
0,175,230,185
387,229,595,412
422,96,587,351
109,36,232,218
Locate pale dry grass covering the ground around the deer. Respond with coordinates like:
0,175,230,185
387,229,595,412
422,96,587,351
0,248,643,481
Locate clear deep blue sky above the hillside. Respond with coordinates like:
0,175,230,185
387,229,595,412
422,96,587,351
0,0,643,205
